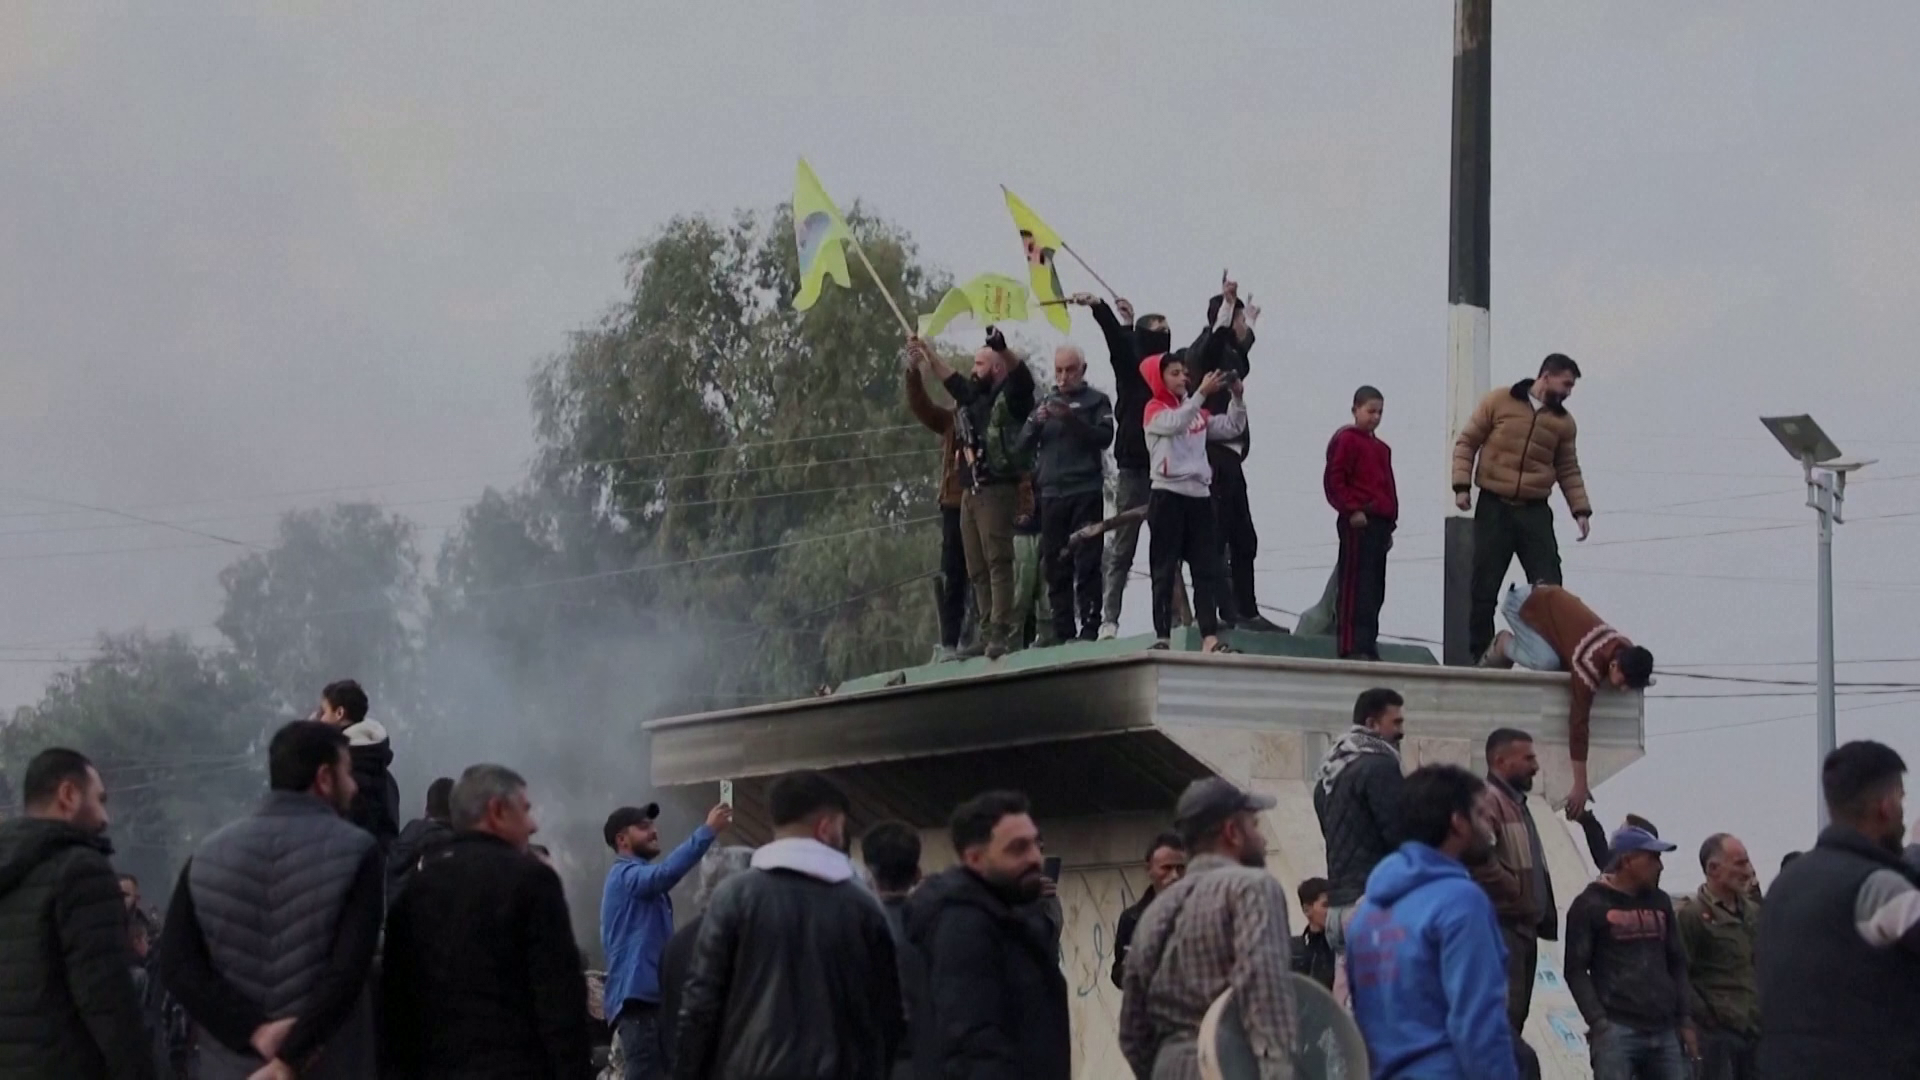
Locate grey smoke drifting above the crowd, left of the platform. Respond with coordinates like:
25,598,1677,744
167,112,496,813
394,613,710,957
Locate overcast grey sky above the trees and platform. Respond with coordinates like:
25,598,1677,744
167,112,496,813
0,0,1920,882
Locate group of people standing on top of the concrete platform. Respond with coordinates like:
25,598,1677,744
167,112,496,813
904,275,1653,691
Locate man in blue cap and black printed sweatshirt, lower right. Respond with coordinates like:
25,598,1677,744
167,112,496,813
1565,826,1699,1080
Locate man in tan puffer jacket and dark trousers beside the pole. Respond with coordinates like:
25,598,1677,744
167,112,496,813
1453,352,1594,657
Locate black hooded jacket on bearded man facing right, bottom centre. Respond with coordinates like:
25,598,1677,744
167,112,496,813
906,867,1073,1080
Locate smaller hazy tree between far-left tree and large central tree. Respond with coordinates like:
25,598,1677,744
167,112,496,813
215,503,420,715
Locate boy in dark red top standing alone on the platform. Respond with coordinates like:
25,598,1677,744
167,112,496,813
1327,386,1400,659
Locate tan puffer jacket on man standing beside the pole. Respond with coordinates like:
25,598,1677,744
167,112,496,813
1453,379,1594,517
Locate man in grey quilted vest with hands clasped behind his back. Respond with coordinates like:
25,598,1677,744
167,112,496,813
159,721,386,1080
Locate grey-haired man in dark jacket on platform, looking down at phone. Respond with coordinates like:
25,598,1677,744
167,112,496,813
1016,344,1114,644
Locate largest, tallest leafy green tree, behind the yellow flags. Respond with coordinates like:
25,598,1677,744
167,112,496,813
495,208,947,711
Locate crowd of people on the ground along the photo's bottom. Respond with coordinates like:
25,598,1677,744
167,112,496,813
0,661,1920,1080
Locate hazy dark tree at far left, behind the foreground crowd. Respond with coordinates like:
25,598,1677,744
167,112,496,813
0,632,278,880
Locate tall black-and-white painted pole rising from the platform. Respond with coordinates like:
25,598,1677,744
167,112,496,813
1442,0,1494,665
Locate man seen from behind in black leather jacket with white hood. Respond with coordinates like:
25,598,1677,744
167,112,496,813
674,773,906,1080
